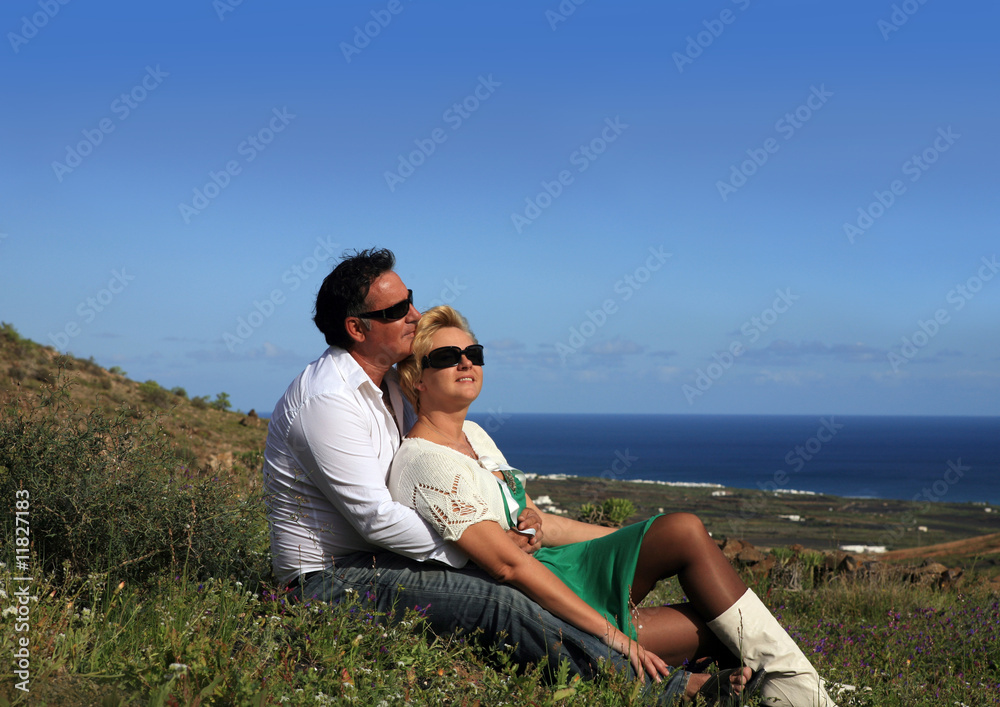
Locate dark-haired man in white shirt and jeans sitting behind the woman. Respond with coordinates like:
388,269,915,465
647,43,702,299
264,249,686,698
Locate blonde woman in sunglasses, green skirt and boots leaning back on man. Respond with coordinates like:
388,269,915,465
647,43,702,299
389,306,833,707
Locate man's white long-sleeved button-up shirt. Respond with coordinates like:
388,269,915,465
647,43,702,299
264,346,467,582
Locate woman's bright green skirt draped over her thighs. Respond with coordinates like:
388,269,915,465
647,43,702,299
535,516,656,639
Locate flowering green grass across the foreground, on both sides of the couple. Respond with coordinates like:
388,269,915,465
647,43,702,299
0,565,1000,707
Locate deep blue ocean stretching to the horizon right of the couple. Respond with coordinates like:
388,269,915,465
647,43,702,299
469,413,1000,505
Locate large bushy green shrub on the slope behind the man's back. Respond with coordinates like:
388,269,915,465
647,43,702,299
0,387,268,580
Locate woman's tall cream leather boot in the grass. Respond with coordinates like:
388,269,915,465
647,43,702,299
708,589,836,707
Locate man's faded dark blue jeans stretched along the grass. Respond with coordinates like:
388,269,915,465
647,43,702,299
293,552,690,705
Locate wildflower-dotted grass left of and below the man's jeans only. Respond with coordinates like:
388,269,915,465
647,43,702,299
0,568,680,705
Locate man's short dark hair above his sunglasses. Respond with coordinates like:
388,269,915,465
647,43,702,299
313,248,396,350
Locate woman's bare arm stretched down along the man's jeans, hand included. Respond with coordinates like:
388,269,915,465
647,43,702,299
455,521,670,681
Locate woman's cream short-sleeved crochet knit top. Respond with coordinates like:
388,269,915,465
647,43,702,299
388,420,510,541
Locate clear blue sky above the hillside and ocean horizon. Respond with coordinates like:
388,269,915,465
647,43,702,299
0,0,1000,415
